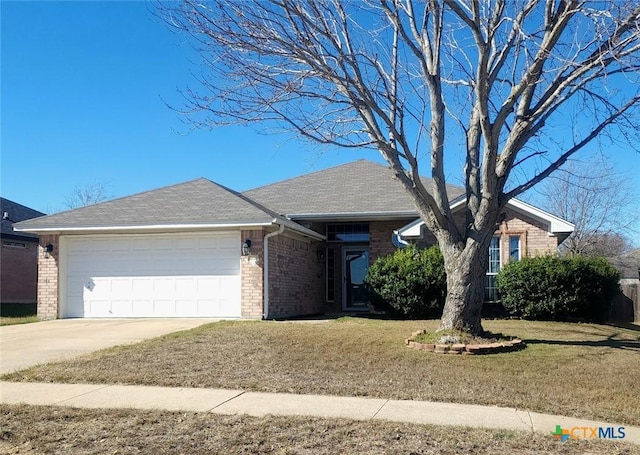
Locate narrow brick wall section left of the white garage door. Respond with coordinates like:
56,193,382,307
38,235,60,320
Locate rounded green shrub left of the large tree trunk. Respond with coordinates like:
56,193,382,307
365,246,447,319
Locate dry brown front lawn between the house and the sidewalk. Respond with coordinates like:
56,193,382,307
5,318,640,425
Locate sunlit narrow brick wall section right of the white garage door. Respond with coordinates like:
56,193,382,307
238,230,265,319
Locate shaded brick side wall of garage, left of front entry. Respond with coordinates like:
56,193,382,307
268,234,325,318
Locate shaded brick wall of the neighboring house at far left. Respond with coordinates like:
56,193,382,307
0,239,38,303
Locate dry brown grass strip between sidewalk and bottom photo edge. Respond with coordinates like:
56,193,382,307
0,405,640,455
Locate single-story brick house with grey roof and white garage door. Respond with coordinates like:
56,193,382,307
18,160,573,319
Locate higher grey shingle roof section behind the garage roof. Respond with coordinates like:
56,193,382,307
243,160,463,216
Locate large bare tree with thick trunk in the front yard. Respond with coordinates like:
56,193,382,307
158,0,640,333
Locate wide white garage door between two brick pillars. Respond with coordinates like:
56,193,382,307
63,232,240,317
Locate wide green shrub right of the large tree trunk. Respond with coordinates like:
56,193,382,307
496,256,620,322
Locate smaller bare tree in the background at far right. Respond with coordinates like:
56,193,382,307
539,157,639,257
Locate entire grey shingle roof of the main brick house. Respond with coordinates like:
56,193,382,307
17,160,462,232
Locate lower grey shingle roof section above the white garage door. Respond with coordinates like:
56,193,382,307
16,178,322,240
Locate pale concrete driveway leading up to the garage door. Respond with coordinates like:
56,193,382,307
0,318,216,374
